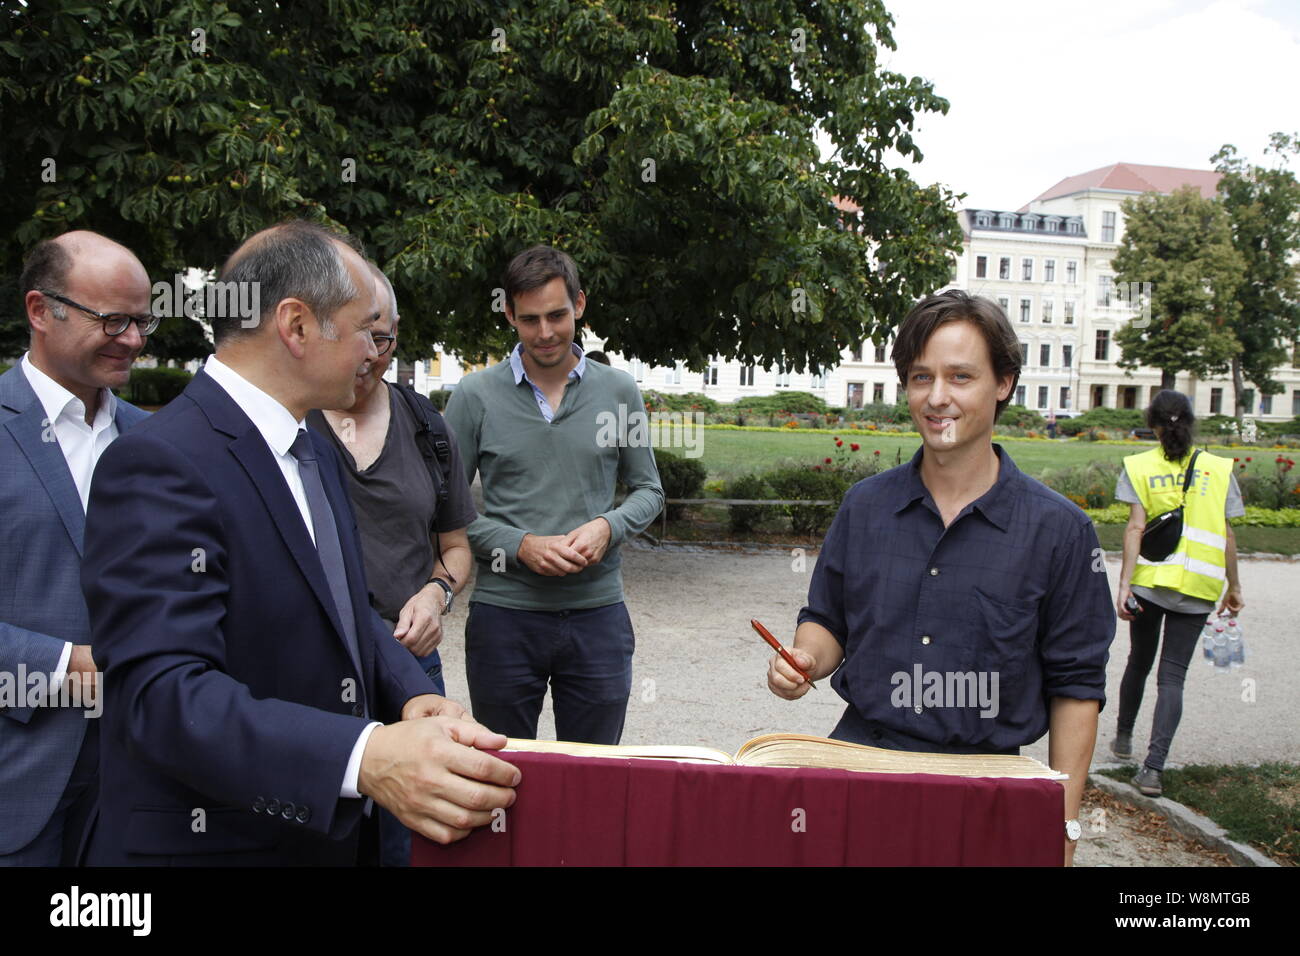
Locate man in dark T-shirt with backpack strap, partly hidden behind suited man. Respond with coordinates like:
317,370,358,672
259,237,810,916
307,263,478,866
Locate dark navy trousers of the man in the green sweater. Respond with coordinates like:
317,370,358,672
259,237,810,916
465,601,636,744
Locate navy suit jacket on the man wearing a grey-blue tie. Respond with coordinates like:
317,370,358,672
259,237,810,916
82,371,434,865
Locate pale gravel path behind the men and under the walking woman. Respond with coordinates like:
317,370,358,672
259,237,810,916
442,541,1300,865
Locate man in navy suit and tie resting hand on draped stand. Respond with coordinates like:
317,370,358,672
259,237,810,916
82,222,519,865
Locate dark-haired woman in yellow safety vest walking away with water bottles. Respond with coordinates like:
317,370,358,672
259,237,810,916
1110,389,1245,796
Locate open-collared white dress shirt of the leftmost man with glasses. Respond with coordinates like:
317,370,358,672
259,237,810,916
22,352,117,695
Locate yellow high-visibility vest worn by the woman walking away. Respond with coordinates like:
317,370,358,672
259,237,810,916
1125,446,1232,601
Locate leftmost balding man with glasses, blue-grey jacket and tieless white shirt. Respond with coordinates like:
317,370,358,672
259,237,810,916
0,232,157,866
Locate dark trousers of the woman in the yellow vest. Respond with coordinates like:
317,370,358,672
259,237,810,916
1117,594,1206,770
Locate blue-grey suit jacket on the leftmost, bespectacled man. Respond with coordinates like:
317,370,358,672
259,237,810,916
0,364,148,855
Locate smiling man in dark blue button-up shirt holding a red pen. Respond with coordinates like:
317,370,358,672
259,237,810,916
768,290,1115,861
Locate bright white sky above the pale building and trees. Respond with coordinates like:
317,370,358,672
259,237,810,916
883,0,1300,209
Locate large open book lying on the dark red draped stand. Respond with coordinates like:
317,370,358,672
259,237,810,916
506,734,1067,780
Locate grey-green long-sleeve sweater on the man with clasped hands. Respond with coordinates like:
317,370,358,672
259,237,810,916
446,362,663,610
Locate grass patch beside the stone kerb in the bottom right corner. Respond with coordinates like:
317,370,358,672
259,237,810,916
1101,763,1300,866
